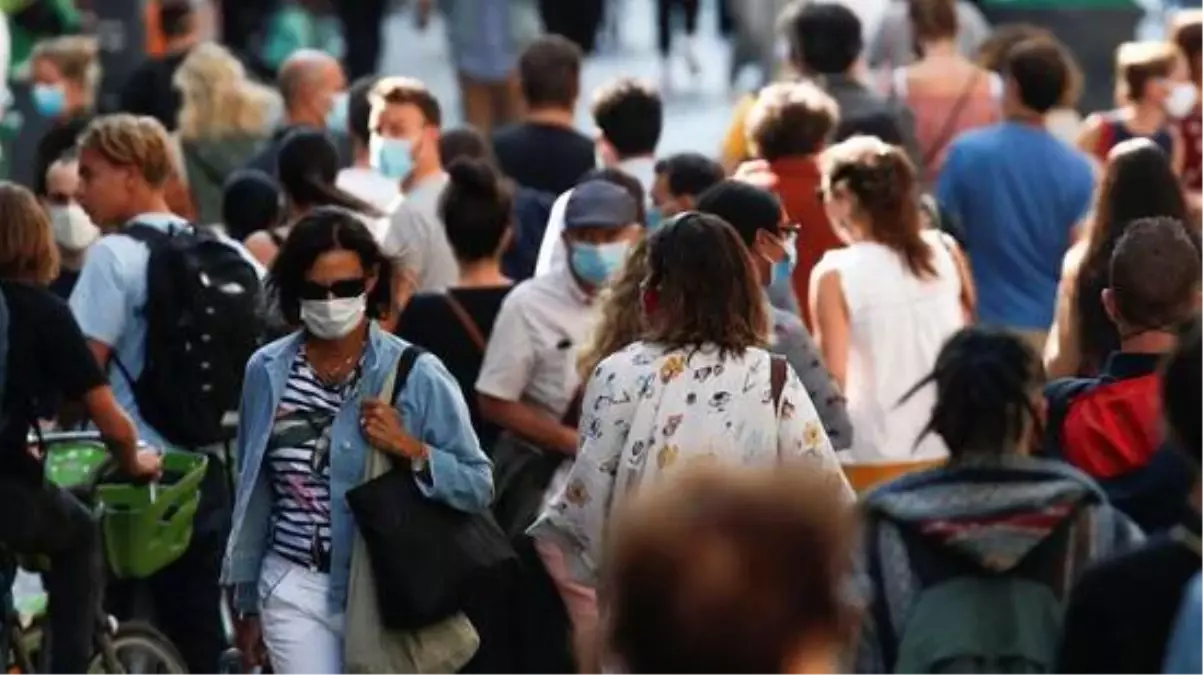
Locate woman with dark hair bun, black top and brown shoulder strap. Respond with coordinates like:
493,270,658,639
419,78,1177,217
397,159,512,454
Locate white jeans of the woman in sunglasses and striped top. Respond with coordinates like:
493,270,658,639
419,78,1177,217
259,553,343,675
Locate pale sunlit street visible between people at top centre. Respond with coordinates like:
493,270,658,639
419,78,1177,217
381,0,731,154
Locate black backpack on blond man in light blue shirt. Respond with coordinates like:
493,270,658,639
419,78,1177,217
115,223,263,449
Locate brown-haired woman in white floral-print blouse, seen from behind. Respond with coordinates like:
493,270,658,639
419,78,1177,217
531,212,851,594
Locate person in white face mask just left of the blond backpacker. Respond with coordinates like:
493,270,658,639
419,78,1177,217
43,155,100,300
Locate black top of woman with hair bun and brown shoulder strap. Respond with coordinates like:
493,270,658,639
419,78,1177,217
397,286,514,454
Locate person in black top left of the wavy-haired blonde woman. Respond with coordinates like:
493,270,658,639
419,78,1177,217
120,0,200,131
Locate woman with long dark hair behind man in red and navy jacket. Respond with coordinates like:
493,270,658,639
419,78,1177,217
1044,138,1191,378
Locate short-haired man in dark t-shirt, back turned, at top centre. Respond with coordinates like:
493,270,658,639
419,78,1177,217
493,35,597,196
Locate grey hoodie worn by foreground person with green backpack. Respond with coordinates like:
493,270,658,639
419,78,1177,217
855,455,1143,675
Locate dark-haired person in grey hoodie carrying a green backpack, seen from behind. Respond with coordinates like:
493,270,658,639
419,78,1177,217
855,327,1140,673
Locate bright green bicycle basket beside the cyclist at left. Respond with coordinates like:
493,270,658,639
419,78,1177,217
46,442,208,579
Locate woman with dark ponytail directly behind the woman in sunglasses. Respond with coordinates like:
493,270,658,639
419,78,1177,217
247,129,381,266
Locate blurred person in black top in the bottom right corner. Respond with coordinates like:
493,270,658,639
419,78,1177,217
1056,227,1203,675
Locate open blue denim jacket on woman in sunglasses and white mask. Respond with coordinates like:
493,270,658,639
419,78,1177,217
221,322,493,612
